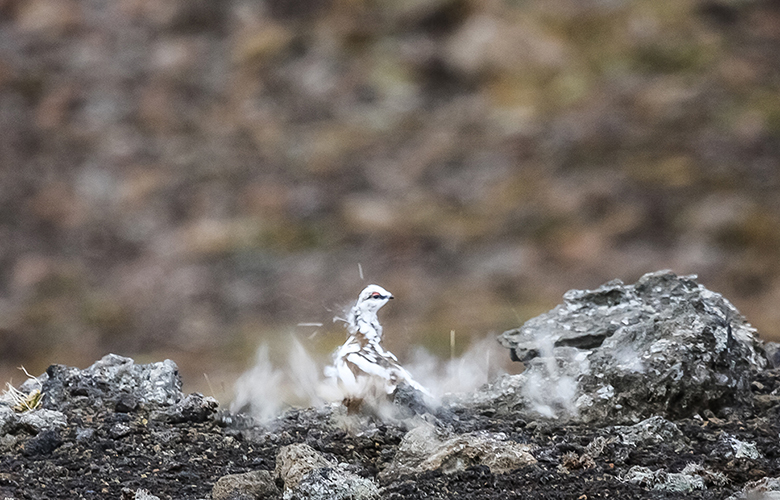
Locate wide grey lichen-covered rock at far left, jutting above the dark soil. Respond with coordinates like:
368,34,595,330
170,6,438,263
38,354,183,411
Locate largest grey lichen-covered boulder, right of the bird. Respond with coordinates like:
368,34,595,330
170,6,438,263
494,271,766,422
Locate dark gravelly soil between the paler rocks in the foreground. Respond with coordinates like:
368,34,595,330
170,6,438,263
0,370,780,500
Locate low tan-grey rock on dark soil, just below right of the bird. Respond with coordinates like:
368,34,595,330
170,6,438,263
379,425,536,481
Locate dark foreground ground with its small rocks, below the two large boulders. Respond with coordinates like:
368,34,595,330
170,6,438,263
7,348,780,500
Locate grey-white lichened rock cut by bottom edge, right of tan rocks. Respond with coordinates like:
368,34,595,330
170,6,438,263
284,464,380,500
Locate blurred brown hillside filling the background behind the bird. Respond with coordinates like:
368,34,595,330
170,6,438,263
0,0,780,398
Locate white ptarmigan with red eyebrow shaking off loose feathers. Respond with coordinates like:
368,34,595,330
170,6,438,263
325,285,428,414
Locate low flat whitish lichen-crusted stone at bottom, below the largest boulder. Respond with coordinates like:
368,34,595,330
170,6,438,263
623,463,728,493
